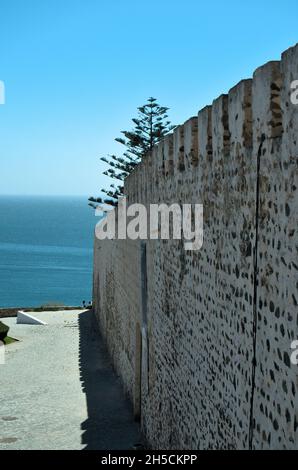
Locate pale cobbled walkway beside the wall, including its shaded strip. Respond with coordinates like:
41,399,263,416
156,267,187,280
0,311,140,450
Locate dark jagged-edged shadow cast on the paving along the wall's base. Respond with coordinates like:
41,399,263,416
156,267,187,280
79,310,140,450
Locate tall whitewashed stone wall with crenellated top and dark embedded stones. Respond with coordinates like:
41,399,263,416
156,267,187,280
94,46,298,449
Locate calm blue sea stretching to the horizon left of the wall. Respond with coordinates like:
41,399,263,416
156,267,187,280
0,196,98,307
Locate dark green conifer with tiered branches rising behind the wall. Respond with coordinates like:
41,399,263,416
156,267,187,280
89,97,174,208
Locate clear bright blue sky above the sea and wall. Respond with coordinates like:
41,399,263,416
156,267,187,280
0,0,298,195
